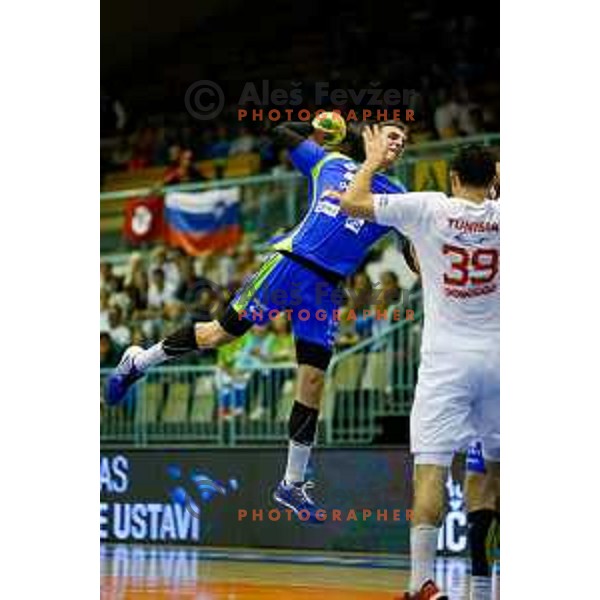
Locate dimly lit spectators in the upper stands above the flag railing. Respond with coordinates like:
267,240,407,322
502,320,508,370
103,79,499,185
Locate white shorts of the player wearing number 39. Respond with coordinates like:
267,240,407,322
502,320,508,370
410,347,500,461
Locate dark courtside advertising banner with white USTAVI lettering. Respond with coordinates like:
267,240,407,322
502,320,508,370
100,448,466,554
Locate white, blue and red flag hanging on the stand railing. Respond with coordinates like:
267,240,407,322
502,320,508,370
165,187,242,256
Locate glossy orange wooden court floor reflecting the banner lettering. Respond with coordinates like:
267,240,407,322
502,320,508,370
101,545,492,600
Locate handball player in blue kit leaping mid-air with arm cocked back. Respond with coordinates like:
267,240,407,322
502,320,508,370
107,116,406,522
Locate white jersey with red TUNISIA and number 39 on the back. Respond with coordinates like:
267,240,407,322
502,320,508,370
374,192,500,352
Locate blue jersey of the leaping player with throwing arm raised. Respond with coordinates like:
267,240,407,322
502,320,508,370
275,140,406,277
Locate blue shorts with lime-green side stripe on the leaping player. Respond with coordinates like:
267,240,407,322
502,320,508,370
229,253,344,350
